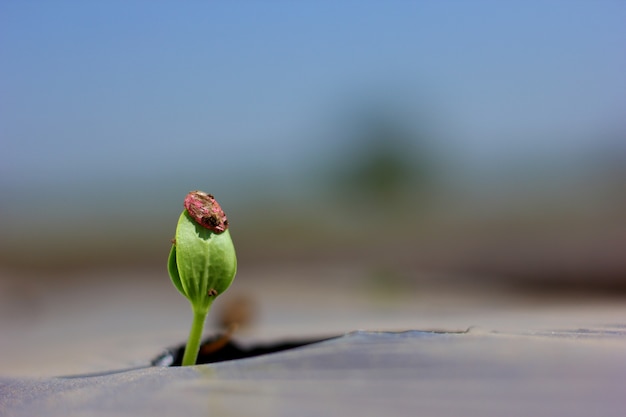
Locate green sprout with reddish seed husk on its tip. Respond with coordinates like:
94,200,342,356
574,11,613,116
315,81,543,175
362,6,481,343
167,191,237,366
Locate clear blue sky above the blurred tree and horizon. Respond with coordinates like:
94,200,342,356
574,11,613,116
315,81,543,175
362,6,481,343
0,0,626,198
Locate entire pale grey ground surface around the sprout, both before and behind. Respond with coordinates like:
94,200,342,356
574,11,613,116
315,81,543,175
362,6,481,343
0,265,626,416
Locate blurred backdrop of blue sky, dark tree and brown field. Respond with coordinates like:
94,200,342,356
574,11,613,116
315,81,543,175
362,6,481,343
0,0,626,372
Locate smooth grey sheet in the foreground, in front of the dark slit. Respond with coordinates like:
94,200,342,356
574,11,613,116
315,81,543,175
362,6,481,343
0,325,626,417
